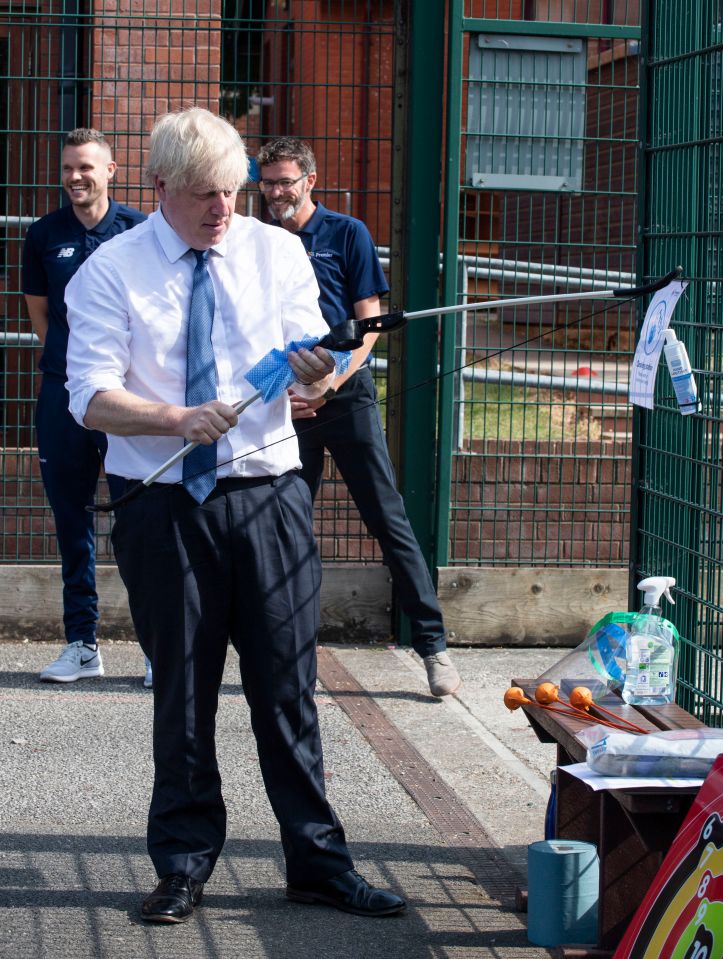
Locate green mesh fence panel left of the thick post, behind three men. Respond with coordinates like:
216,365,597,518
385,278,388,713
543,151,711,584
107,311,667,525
0,0,398,562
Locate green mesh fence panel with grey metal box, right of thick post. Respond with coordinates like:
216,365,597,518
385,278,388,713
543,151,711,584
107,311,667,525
436,0,640,567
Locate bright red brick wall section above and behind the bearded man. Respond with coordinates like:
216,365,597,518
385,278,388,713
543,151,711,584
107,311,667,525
252,0,394,245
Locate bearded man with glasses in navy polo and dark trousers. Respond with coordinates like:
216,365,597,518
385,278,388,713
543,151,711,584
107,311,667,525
256,137,461,696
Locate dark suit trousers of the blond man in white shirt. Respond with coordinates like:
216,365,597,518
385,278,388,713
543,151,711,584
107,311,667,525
113,473,352,882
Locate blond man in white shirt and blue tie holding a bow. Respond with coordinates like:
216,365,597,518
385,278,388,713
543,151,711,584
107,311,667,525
67,107,405,922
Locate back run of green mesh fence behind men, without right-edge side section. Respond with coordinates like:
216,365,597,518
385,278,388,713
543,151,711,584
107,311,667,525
0,0,652,584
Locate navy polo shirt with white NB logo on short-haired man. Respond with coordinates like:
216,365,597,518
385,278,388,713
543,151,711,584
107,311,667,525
23,200,146,379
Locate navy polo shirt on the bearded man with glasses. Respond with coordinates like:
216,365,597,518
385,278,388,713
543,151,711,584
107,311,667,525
296,203,389,327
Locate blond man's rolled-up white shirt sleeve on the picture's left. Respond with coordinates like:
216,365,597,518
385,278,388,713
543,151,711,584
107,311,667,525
65,250,131,426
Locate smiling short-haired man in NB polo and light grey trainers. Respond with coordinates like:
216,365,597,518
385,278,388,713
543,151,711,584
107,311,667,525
23,127,153,687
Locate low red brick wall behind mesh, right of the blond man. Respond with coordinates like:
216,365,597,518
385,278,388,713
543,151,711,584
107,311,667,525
316,440,631,566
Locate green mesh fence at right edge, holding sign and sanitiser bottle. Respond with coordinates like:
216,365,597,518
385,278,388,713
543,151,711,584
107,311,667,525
632,0,723,725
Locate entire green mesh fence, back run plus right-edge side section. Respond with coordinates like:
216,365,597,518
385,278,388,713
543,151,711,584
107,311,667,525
5,0,723,720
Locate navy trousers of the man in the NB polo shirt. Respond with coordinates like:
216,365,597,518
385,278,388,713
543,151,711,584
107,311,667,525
35,375,125,643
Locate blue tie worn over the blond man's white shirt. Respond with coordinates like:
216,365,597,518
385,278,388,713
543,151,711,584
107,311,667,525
183,250,218,503
